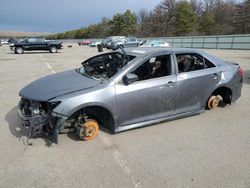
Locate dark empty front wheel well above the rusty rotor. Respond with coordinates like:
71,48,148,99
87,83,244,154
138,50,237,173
72,106,115,133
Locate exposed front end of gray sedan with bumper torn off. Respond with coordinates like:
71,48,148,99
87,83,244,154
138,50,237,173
18,98,64,143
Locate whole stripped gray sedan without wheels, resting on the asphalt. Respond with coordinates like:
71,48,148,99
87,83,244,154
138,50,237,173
18,48,243,143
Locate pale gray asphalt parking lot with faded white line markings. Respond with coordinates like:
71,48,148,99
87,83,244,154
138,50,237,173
0,44,250,188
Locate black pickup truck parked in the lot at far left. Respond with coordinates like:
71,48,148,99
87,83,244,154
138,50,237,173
10,37,63,54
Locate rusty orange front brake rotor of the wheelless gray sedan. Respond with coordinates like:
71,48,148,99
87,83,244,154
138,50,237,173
82,119,99,141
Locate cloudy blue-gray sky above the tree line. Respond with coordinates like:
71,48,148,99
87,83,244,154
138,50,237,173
0,0,162,32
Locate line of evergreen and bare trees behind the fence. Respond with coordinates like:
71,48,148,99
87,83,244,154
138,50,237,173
47,0,250,39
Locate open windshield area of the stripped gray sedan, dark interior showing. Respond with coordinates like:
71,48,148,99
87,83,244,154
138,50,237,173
78,52,135,81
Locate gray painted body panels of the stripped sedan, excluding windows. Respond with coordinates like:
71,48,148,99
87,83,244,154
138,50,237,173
20,48,242,132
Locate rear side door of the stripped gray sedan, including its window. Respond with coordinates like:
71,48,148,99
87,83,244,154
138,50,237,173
175,53,221,114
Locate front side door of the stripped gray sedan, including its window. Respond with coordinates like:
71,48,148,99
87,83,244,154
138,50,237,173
115,54,176,126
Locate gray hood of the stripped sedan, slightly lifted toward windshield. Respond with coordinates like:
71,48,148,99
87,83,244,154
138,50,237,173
19,70,100,101
